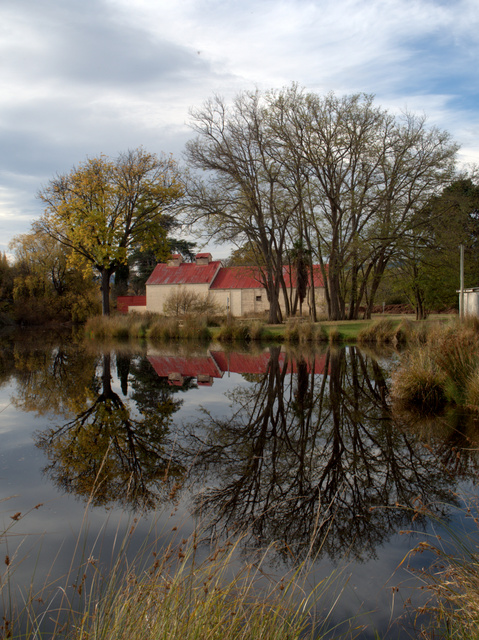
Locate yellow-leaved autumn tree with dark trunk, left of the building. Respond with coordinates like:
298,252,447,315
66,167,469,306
38,148,183,315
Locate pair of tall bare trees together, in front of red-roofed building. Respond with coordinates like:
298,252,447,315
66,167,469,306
186,85,458,322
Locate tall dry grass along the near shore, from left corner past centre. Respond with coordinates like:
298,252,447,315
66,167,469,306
0,504,350,640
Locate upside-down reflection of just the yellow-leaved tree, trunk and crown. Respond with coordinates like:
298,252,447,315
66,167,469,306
37,354,185,508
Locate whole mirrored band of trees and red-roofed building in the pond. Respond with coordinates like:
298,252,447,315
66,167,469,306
5,342,478,560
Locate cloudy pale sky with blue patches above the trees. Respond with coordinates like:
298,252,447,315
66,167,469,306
0,0,479,258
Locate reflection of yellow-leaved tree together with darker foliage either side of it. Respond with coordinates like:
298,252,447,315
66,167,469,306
13,346,185,509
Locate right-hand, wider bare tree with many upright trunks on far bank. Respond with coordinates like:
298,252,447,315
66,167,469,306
269,85,458,319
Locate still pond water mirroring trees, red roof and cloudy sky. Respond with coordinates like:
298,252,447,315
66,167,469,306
0,334,479,637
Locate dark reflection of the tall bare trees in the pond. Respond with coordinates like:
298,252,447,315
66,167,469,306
184,347,464,558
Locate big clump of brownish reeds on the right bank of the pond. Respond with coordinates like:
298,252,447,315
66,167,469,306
392,321,479,411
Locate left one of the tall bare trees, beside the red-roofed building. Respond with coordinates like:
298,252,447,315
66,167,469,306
186,92,298,323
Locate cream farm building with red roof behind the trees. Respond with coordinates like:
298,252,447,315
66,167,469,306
119,253,325,317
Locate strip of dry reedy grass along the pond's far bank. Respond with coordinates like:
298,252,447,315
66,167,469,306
85,314,456,346
